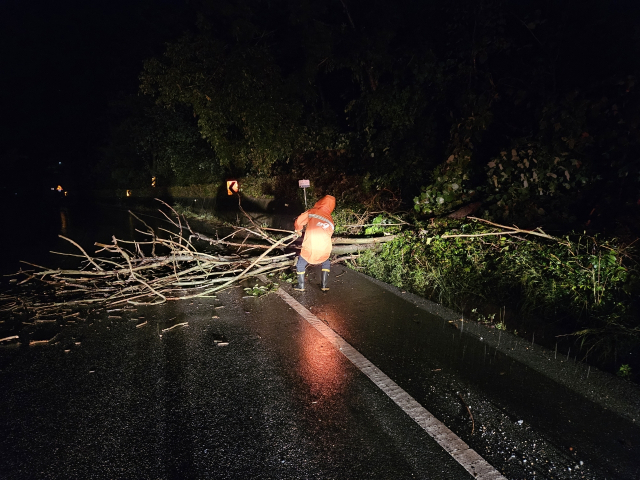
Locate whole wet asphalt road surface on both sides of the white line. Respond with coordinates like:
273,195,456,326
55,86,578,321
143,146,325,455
0,204,640,479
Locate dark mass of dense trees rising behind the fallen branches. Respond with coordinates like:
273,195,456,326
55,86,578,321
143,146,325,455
104,0,640,229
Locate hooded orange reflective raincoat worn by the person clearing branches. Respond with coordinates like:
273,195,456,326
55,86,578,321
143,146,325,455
294,195,336,265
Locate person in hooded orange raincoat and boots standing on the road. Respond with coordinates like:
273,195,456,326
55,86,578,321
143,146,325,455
293,195,336,292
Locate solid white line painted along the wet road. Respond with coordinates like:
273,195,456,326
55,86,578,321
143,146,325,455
277,288,507,480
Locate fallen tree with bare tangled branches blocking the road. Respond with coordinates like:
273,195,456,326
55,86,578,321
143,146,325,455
0,202,395,316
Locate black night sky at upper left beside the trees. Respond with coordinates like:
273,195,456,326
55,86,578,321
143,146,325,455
0,0,194,188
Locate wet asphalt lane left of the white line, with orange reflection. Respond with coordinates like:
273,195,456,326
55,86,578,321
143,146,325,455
0,272,476,479
